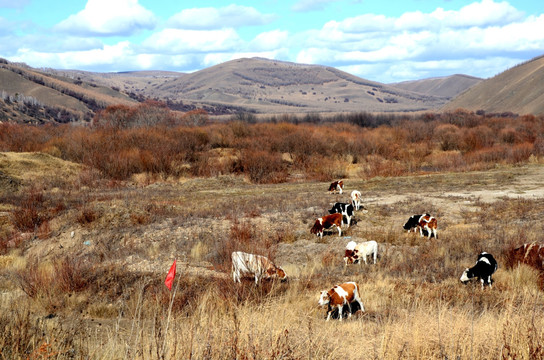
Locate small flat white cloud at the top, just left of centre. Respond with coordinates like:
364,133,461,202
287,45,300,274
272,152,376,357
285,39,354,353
167,4,275,30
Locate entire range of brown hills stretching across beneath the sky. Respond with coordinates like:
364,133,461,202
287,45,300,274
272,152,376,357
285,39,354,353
0,57,544,123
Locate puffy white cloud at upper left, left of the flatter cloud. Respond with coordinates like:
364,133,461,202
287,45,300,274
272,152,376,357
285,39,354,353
55,0,157,36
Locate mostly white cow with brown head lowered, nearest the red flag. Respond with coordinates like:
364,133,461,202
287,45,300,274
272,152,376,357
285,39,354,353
231,251,287,285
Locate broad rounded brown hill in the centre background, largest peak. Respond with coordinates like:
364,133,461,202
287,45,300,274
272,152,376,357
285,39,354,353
154,58,445,113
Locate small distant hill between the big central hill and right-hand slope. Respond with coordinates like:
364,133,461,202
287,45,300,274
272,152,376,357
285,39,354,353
390,74,482,99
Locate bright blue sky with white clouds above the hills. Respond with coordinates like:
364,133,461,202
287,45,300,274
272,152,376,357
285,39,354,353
0,0,544,83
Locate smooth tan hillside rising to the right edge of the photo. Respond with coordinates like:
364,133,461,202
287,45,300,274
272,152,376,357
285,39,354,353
443,56,544,115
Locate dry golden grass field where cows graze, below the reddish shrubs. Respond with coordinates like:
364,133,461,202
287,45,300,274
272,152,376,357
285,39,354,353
0,148,544,359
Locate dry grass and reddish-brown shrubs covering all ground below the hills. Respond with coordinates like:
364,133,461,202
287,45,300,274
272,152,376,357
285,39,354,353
0,107,544,359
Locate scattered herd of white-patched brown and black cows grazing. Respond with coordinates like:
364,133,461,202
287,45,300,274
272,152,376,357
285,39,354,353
232,180,506,321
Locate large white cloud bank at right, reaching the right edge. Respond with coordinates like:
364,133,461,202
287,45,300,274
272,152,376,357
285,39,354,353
296,0,544,81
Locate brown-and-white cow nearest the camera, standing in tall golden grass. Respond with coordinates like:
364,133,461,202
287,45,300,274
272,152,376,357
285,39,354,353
318,282,365,321
